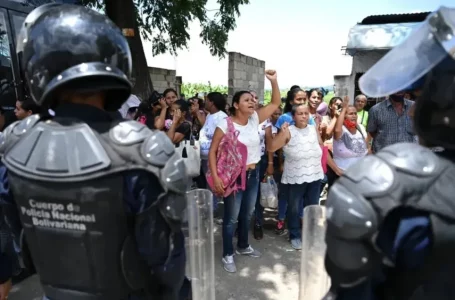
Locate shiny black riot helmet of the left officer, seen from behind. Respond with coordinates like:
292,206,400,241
16,4,132,111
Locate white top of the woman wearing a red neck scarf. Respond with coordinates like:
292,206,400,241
333,124,368,170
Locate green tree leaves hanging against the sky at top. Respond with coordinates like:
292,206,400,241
80,0,249,57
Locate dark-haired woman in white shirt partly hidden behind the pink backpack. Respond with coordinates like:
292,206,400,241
199,92,227,212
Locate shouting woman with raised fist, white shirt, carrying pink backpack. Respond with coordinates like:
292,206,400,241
209,70,281,273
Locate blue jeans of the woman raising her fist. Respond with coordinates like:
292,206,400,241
223,168,259,257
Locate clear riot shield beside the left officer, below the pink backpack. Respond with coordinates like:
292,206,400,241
187,189,215,300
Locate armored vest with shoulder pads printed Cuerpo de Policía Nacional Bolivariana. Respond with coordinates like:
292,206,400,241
0,115,186,300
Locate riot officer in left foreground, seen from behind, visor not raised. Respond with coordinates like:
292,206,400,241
0,4,187,300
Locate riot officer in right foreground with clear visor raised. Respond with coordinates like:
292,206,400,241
326,7,455,300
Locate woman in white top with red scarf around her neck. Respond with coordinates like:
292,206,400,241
327,97,368,186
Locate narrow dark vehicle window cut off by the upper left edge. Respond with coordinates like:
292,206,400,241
0,11,16,110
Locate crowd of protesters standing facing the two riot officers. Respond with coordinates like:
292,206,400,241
114,71,415,272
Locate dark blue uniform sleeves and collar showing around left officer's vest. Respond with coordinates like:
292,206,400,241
0,104,185,300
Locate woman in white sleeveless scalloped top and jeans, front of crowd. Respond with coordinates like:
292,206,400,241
268,104,324,250
